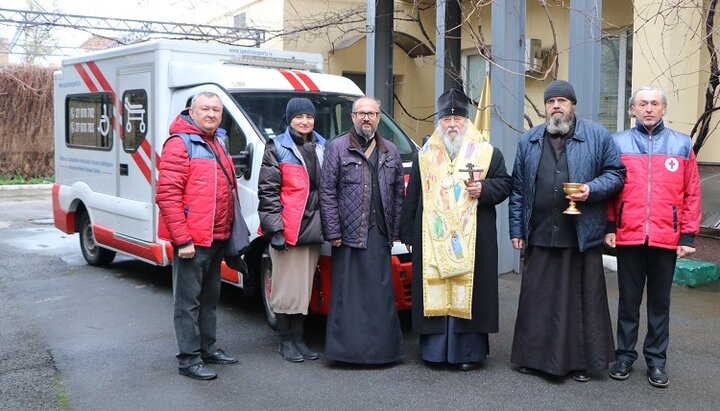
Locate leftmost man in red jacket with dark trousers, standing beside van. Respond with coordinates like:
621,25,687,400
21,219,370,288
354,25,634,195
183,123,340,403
156,92,242,380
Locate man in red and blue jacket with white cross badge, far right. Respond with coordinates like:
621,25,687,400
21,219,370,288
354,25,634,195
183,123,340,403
605,86,700,388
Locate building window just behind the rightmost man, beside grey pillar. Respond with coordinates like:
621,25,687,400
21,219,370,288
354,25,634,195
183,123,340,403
598,30,632,132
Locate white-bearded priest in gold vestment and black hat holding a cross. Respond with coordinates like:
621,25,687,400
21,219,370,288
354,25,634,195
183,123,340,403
400,89,512,371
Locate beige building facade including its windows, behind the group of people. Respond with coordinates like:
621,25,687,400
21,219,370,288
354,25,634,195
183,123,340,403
210,0,720,163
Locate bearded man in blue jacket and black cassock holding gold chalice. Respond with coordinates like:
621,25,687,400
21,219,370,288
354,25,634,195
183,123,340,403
508,80,625,382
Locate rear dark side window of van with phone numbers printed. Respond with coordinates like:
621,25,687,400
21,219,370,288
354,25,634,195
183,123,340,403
65,92,113,150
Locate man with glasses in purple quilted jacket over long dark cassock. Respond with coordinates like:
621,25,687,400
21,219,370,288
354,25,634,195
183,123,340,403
320,96,405,364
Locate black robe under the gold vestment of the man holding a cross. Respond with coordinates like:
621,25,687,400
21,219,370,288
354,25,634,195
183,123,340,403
400,149,512,363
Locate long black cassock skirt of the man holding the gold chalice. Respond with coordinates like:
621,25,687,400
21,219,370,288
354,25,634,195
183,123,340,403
510,246,615,376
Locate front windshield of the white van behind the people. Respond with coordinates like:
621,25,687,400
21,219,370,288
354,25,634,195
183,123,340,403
232,91,417,162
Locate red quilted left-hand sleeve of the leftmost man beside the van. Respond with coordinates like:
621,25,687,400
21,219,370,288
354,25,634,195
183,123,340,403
155,137,192,246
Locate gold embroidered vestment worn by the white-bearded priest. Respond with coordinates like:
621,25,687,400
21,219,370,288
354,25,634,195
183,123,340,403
418,127,493,319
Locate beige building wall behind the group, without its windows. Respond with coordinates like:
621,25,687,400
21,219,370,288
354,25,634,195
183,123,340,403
208,0,720,163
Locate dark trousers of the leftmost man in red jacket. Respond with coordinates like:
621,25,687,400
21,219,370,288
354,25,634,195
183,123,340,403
172,241,224,368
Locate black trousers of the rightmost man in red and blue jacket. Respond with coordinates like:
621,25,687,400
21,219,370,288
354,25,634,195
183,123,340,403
615,245,676,367
